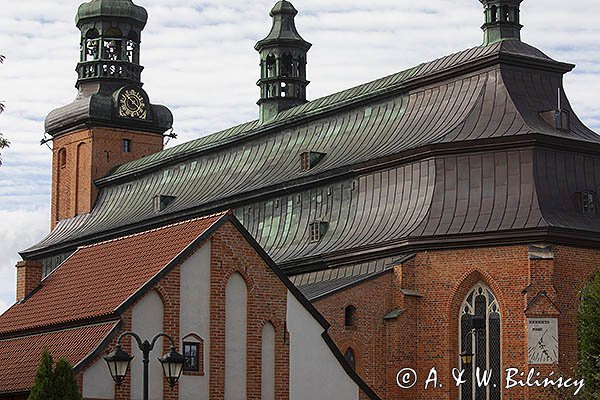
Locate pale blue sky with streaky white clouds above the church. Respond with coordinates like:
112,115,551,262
0,0,600,312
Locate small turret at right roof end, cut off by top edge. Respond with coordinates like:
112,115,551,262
479,0,523,45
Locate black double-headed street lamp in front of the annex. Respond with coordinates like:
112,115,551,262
104,332,185,400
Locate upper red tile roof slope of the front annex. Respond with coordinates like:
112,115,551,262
0,213,225,337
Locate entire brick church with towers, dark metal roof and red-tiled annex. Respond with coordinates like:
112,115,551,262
0,0,600,400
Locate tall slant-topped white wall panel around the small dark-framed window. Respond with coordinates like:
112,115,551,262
179,241,210,400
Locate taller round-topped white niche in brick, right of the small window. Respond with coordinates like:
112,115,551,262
225,273,248,400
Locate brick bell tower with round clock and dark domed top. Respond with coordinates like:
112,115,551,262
45,0,173,228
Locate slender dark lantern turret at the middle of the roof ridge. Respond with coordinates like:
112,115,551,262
255,0,312,123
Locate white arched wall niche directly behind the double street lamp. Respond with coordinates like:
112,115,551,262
131,290,164,400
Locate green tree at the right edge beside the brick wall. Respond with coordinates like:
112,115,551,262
577,272,600,400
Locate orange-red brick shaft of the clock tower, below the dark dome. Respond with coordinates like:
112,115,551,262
51,127,163,229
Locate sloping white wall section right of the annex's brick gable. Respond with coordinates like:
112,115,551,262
287,291,359,400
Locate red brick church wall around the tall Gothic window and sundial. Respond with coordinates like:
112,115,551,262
315,246,600,400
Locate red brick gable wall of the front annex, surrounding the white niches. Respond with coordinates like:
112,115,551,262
79,222,290,400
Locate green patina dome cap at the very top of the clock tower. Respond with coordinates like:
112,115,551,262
75,0,148,25
